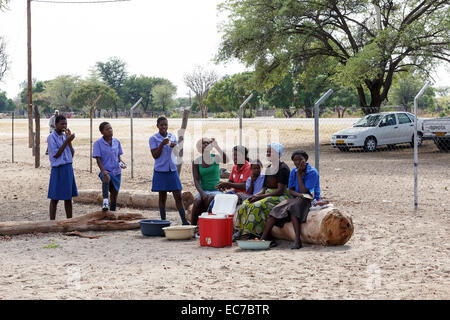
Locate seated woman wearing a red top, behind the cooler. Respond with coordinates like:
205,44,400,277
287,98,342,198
208,146,252,212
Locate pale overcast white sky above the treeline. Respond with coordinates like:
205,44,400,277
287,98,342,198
0,0,450,98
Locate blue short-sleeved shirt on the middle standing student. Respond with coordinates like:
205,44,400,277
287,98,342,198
92,137,123,176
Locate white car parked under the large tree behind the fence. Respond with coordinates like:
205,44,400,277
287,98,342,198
331,112,423,152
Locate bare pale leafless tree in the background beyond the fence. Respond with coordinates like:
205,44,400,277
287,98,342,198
184,66,219,118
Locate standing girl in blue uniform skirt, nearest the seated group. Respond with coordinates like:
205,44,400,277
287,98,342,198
149,117,189,225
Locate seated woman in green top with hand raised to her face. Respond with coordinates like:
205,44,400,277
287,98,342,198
191,138,227,225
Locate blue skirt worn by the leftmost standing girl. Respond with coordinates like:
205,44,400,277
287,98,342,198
47,163,78,200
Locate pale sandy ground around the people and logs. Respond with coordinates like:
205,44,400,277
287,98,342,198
0,119,450,299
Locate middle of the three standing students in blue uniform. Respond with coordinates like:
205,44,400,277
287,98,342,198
92,122,126,211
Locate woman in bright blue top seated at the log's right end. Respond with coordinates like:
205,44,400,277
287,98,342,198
261,150,320,249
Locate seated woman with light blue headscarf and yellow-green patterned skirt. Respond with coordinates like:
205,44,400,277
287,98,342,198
233,143,290,240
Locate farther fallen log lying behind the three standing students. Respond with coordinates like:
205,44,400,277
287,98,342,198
73,189,194,210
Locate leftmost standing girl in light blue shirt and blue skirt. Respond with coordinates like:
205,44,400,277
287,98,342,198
47,115,78,220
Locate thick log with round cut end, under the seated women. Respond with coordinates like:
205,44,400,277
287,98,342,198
272,208,354,246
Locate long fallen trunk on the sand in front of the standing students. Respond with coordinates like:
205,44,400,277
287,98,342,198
0,211,145,236
